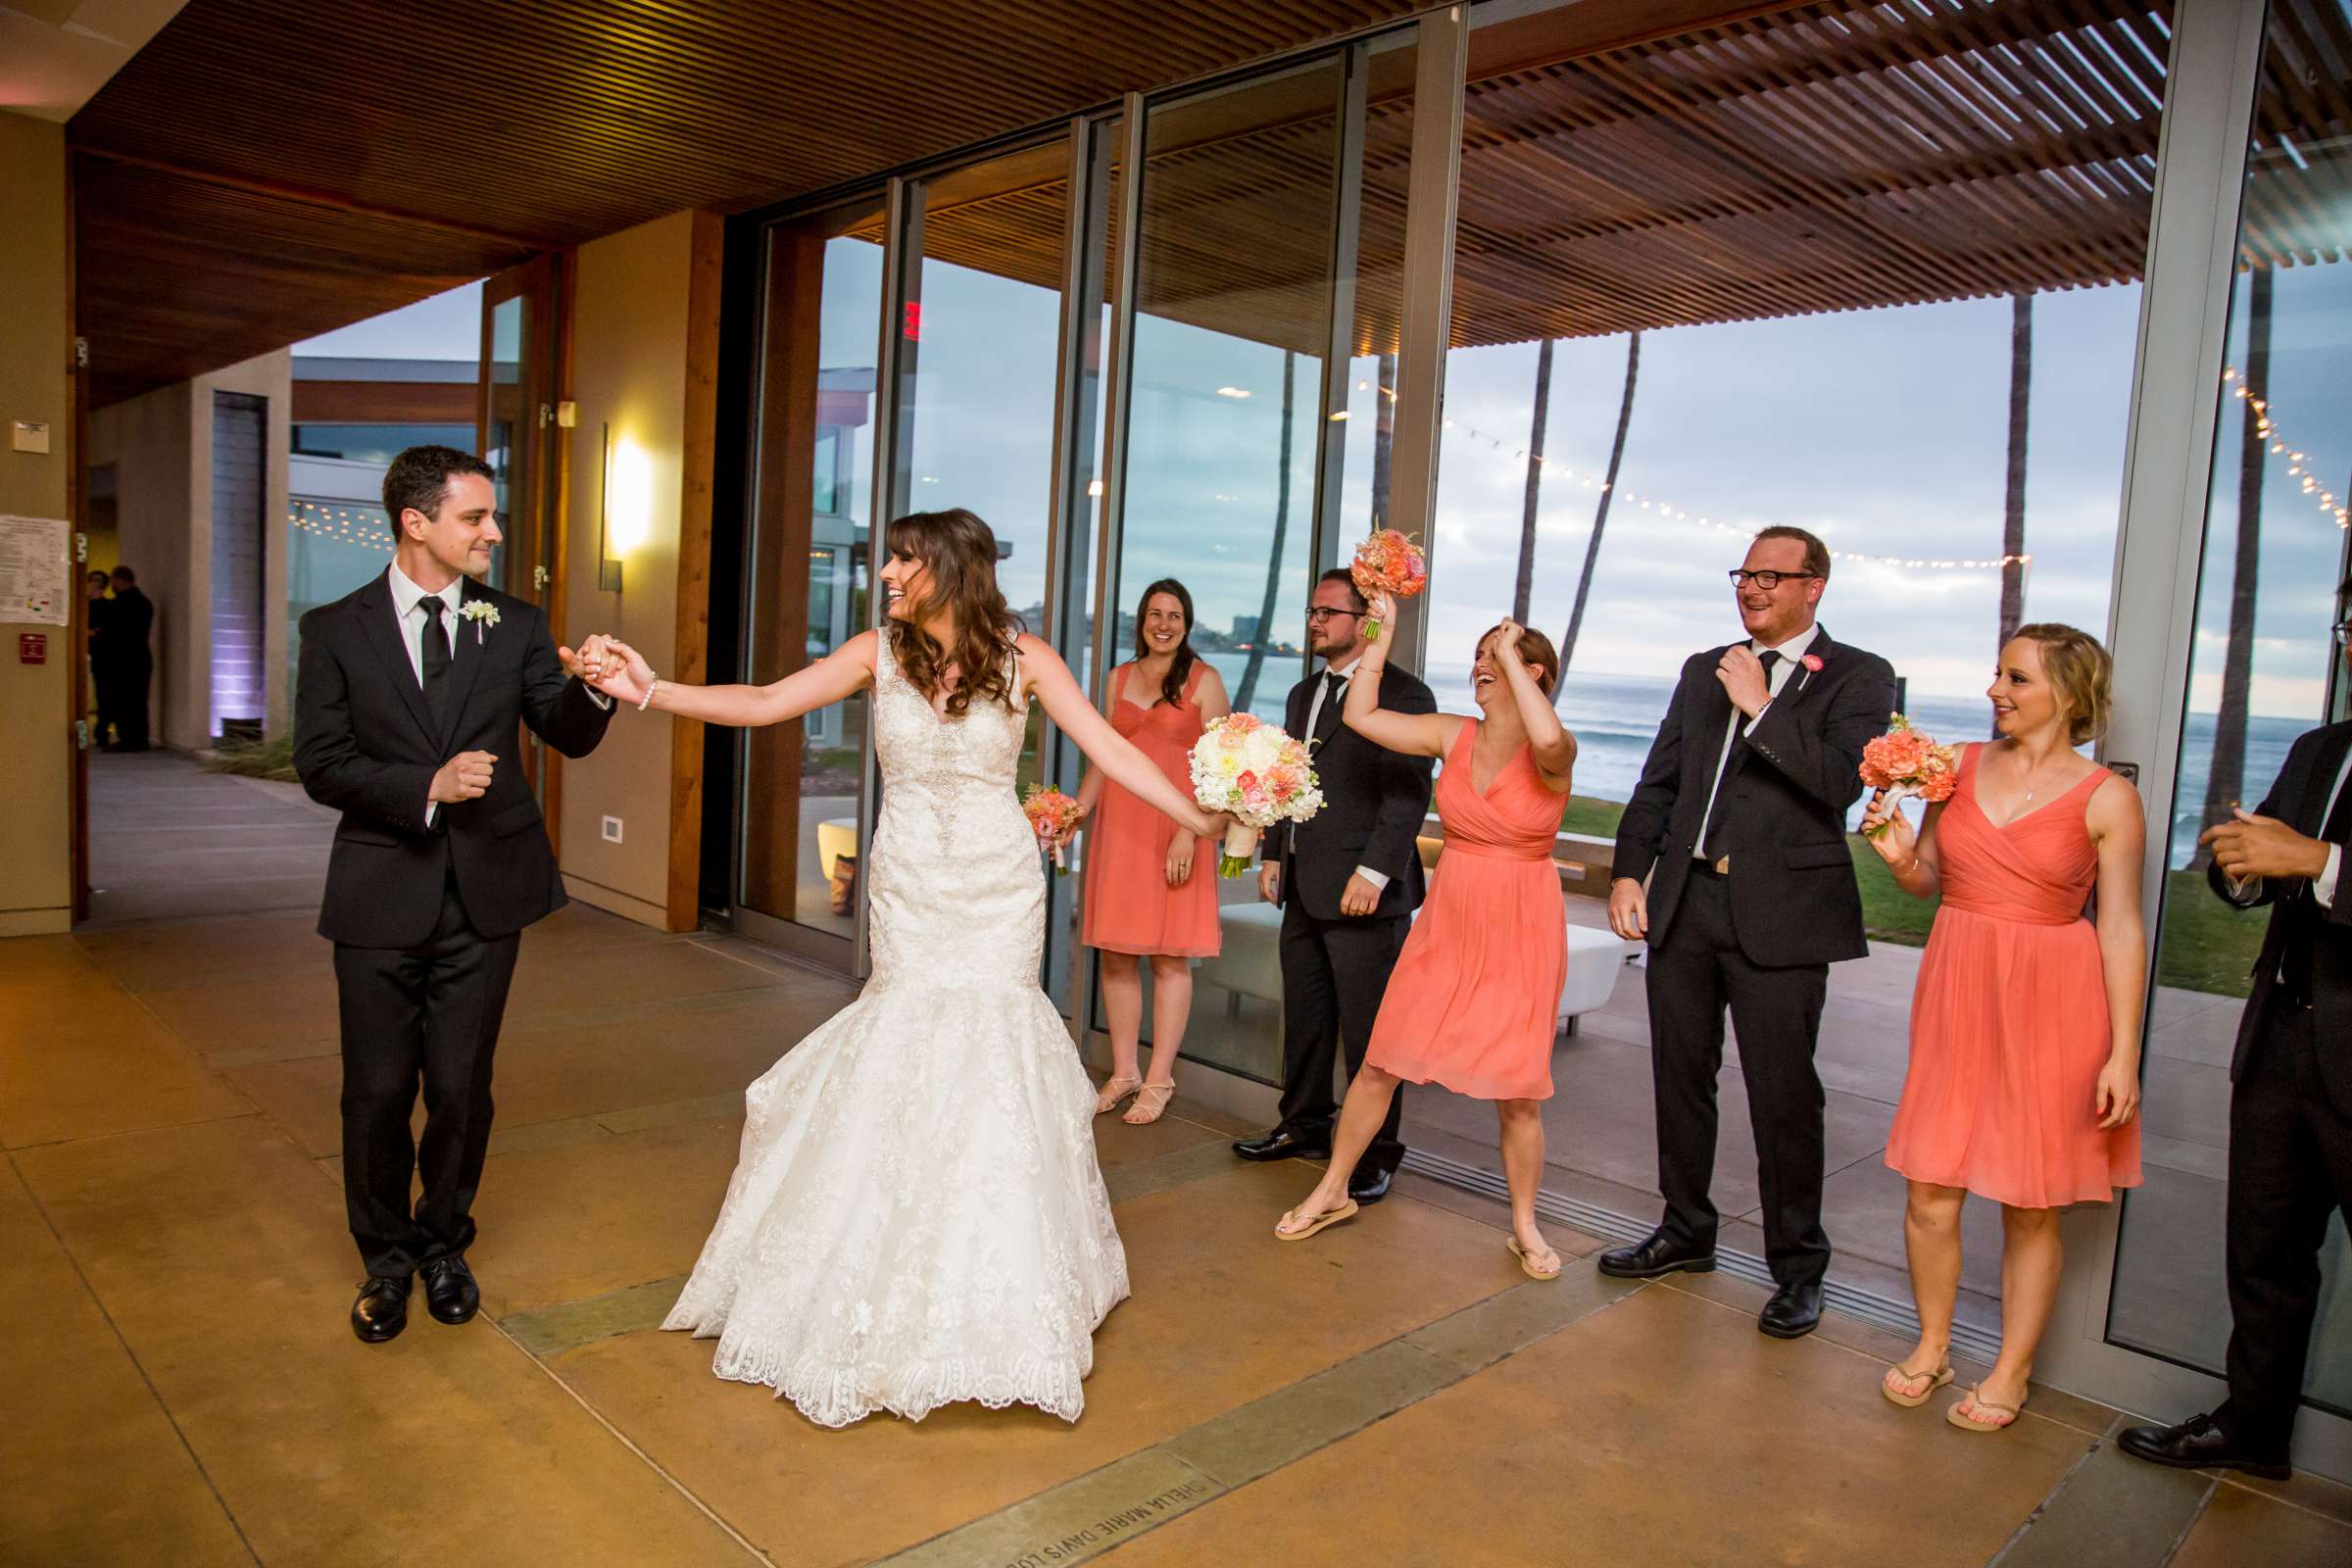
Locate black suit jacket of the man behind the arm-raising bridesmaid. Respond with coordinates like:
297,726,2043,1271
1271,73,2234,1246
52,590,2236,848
1258,665,1437,919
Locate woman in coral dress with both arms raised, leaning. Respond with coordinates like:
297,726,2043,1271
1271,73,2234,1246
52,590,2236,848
1275,597,1576,1279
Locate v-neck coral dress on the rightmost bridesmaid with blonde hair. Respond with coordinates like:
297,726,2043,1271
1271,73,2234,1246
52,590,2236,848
1886,745,2140,1208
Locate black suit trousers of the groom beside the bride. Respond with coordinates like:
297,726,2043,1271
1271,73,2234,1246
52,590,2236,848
334,874,522,1274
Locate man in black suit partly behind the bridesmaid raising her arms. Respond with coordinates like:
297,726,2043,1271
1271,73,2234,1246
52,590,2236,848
1233,569,1437,1203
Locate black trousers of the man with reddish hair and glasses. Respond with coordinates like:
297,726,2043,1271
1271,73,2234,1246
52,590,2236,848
1648,872,1830,1286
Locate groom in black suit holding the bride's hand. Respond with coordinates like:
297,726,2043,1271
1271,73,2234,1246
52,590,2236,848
294,447,612,1345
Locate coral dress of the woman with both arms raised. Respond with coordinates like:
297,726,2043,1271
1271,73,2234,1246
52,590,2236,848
1364,719,1569,1101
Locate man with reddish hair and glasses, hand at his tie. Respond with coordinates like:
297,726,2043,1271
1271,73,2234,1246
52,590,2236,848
1599,529,1895,1340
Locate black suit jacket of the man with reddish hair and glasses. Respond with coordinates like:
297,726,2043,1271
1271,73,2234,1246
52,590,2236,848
1611,627,1895,966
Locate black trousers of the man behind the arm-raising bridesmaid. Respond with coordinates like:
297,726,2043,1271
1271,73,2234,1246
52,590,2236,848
1282,896,1411,1171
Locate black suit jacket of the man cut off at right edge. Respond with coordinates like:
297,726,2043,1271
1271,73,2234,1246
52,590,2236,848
2206,721,2352,1114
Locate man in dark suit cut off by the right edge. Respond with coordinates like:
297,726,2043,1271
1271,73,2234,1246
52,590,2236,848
2117,578,2352,1481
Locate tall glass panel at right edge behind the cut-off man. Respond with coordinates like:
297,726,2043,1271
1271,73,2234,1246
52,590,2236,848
2107,0,2352,1413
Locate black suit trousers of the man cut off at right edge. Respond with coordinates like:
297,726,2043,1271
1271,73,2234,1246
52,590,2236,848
2221,992,2352,1460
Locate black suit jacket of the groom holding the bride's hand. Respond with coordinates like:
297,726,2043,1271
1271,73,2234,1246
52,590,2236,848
294,576,612,948
